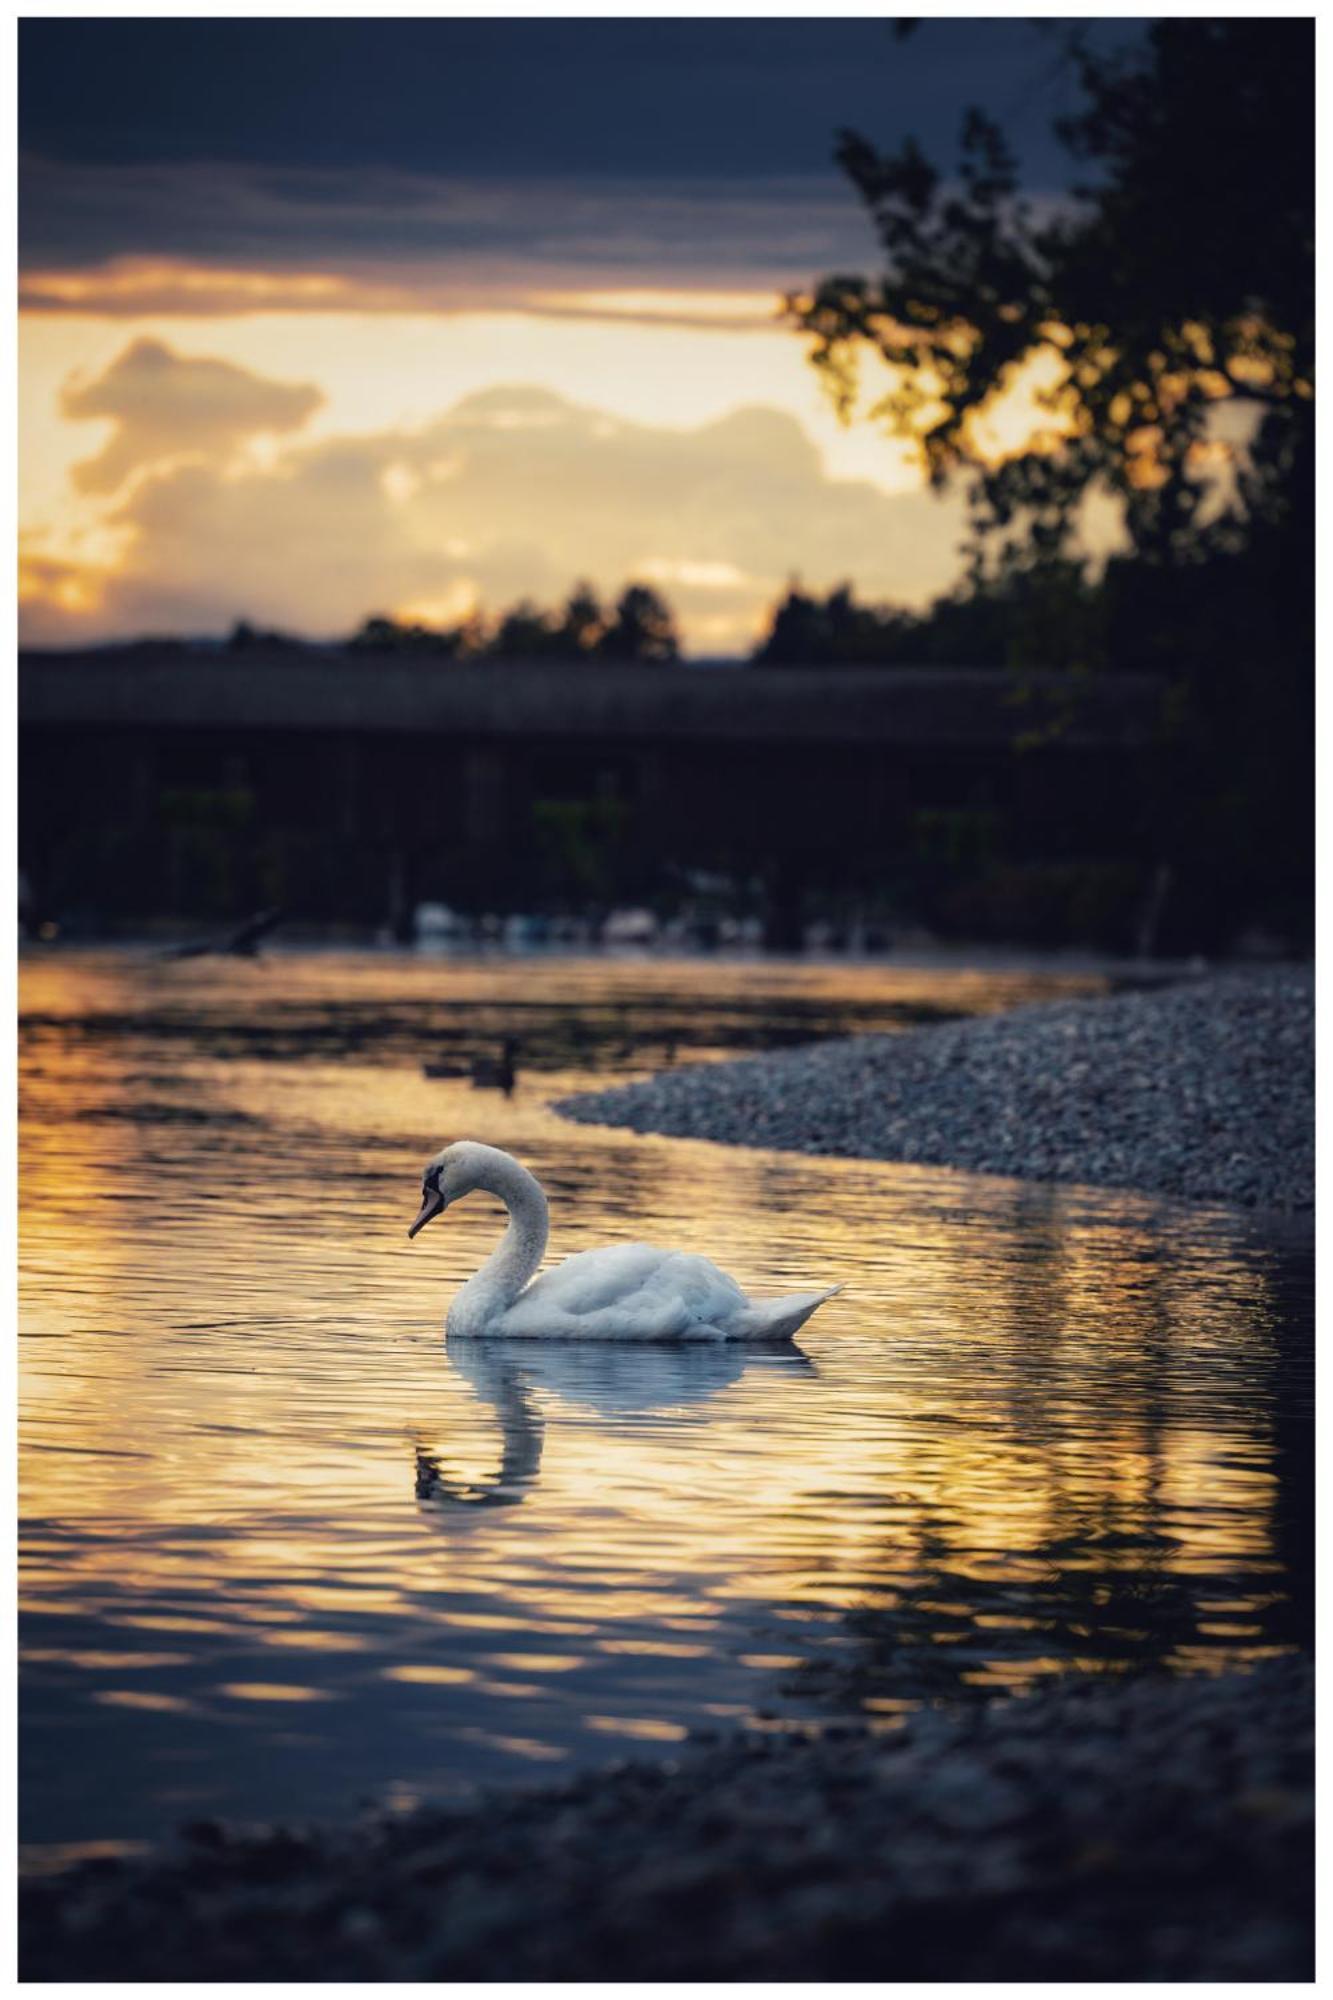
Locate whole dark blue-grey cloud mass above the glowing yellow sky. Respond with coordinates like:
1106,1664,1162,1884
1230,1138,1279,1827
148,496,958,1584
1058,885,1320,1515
20,18,1143,284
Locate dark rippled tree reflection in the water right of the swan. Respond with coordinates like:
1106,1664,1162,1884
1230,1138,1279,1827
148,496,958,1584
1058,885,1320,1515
793,1186,1313,1704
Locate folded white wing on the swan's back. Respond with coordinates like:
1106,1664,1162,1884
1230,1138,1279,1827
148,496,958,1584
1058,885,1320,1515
496,1244,749,1340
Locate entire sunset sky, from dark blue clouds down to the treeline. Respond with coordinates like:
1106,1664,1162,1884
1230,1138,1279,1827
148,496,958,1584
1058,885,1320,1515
20,20,1141,654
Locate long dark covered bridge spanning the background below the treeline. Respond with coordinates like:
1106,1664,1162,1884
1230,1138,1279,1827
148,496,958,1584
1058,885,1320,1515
18,644,1161,942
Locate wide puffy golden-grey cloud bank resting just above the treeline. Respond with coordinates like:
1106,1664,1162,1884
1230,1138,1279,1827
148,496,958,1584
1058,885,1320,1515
26,386,961,650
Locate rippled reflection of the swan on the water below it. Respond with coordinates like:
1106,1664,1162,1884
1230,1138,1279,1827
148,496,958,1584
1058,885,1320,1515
412,1334,815,1512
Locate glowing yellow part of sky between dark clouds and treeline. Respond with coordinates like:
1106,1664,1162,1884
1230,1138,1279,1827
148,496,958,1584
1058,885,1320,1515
20,288,1096,652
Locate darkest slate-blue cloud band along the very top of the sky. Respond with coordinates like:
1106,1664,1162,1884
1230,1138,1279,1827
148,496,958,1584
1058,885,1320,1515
20,18,1143,184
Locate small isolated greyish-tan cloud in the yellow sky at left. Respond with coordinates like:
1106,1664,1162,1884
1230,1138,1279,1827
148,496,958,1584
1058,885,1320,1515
60,340,324,494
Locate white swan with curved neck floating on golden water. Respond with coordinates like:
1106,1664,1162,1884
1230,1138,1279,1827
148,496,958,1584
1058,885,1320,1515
408,1138,841,1340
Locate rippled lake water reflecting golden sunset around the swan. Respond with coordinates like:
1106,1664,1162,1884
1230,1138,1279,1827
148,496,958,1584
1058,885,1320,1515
20,952,1313,1866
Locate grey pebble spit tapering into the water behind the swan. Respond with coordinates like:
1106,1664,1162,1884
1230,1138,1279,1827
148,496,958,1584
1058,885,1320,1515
556,968,1315,1214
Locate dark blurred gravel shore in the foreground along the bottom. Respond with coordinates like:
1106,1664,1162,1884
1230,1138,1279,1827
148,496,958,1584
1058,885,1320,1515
20,1658,1313,1982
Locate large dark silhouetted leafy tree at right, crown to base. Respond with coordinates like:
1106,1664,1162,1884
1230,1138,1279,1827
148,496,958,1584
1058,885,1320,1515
789,18,1315,942
